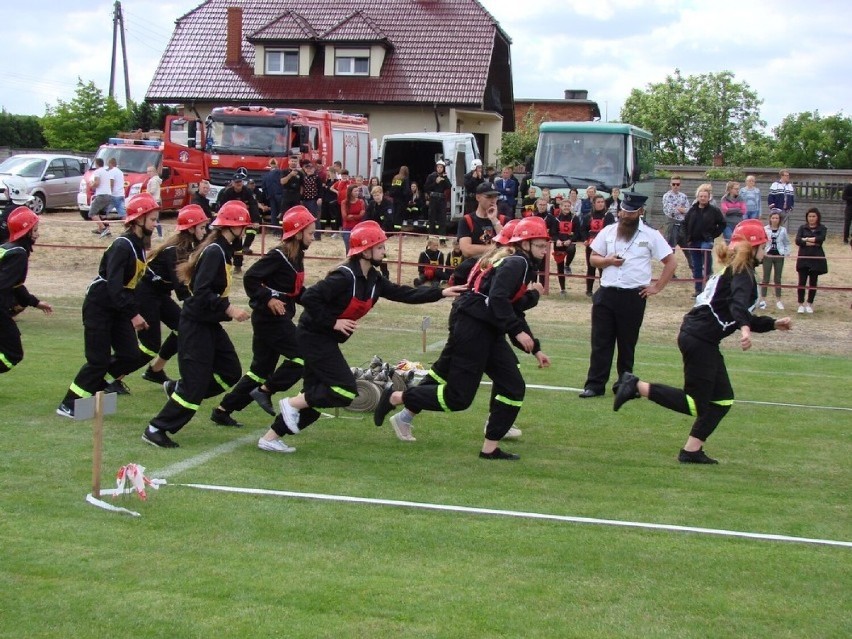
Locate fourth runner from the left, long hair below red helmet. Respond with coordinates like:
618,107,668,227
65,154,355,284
142,200,252,448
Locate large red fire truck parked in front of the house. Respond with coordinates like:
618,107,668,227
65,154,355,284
163,106,370,201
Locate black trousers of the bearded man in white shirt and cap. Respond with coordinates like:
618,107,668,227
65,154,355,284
585,286,645,393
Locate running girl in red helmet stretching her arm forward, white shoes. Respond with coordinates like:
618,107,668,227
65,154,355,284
271,221,465,450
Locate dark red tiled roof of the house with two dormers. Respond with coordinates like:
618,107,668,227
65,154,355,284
146,0,512,109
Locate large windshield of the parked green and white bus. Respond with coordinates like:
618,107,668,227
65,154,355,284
534,131,629,191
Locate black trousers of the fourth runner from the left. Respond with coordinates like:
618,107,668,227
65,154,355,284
151,316,242,433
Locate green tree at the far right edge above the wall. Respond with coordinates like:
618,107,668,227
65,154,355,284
773,111,852,169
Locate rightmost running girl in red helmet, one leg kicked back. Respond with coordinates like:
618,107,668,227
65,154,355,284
612,220,791,464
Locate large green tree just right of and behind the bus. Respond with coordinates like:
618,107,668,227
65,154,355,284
621,69,766,164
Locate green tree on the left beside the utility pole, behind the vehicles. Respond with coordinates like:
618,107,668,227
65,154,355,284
42,78,130,152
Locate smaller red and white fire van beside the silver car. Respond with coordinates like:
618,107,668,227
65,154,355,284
77,132,204,213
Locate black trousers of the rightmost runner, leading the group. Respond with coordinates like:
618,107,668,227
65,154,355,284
648,332,734,441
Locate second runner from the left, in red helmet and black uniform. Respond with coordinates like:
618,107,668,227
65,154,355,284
56,193,160,418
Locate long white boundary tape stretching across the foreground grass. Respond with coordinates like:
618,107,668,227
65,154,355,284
178,484,852,548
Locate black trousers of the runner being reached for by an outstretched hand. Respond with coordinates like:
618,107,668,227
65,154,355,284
402,313,526,441
